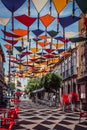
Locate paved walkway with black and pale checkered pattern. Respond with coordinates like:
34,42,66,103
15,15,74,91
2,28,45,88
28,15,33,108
14,100,87,130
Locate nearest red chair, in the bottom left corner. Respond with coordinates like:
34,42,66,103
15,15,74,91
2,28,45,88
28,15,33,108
0,118,15,130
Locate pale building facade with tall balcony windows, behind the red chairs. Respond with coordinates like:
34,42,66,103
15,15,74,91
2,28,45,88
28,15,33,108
52,46,78,96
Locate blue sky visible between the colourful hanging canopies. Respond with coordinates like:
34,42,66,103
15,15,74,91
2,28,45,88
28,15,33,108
0,0,81,85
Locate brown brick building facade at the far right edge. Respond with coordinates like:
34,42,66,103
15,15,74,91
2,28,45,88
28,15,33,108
77,14,87,110
